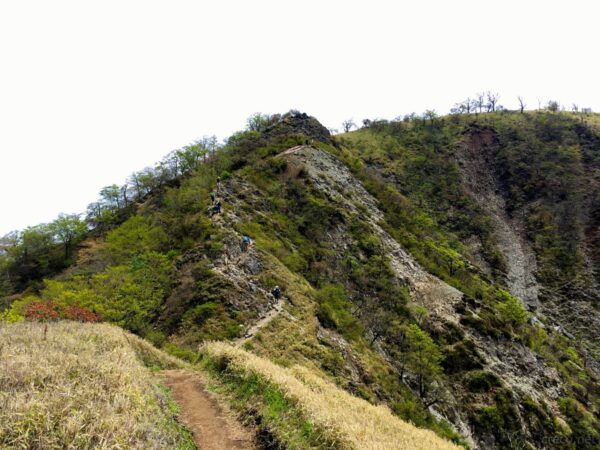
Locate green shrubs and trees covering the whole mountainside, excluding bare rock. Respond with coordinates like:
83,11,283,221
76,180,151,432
0,112,600,448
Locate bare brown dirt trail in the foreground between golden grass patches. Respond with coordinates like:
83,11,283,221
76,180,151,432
163,370,256,450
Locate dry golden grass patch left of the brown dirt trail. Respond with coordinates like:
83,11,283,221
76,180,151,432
0,322,193,449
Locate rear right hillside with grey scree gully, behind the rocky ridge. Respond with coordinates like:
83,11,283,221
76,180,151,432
345,112,600,364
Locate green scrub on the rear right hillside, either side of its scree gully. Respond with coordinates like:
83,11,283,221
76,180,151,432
342,112,600,290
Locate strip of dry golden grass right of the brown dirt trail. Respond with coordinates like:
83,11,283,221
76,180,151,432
203,342,460,450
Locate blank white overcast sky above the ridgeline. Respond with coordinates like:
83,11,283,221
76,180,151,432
0,0,600,235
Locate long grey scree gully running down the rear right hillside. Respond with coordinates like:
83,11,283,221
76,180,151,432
455,129,600,369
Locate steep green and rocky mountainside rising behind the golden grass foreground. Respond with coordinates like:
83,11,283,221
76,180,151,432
3,112,600,449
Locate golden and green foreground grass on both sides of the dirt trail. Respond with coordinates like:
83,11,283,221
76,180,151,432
0,321,455,449
